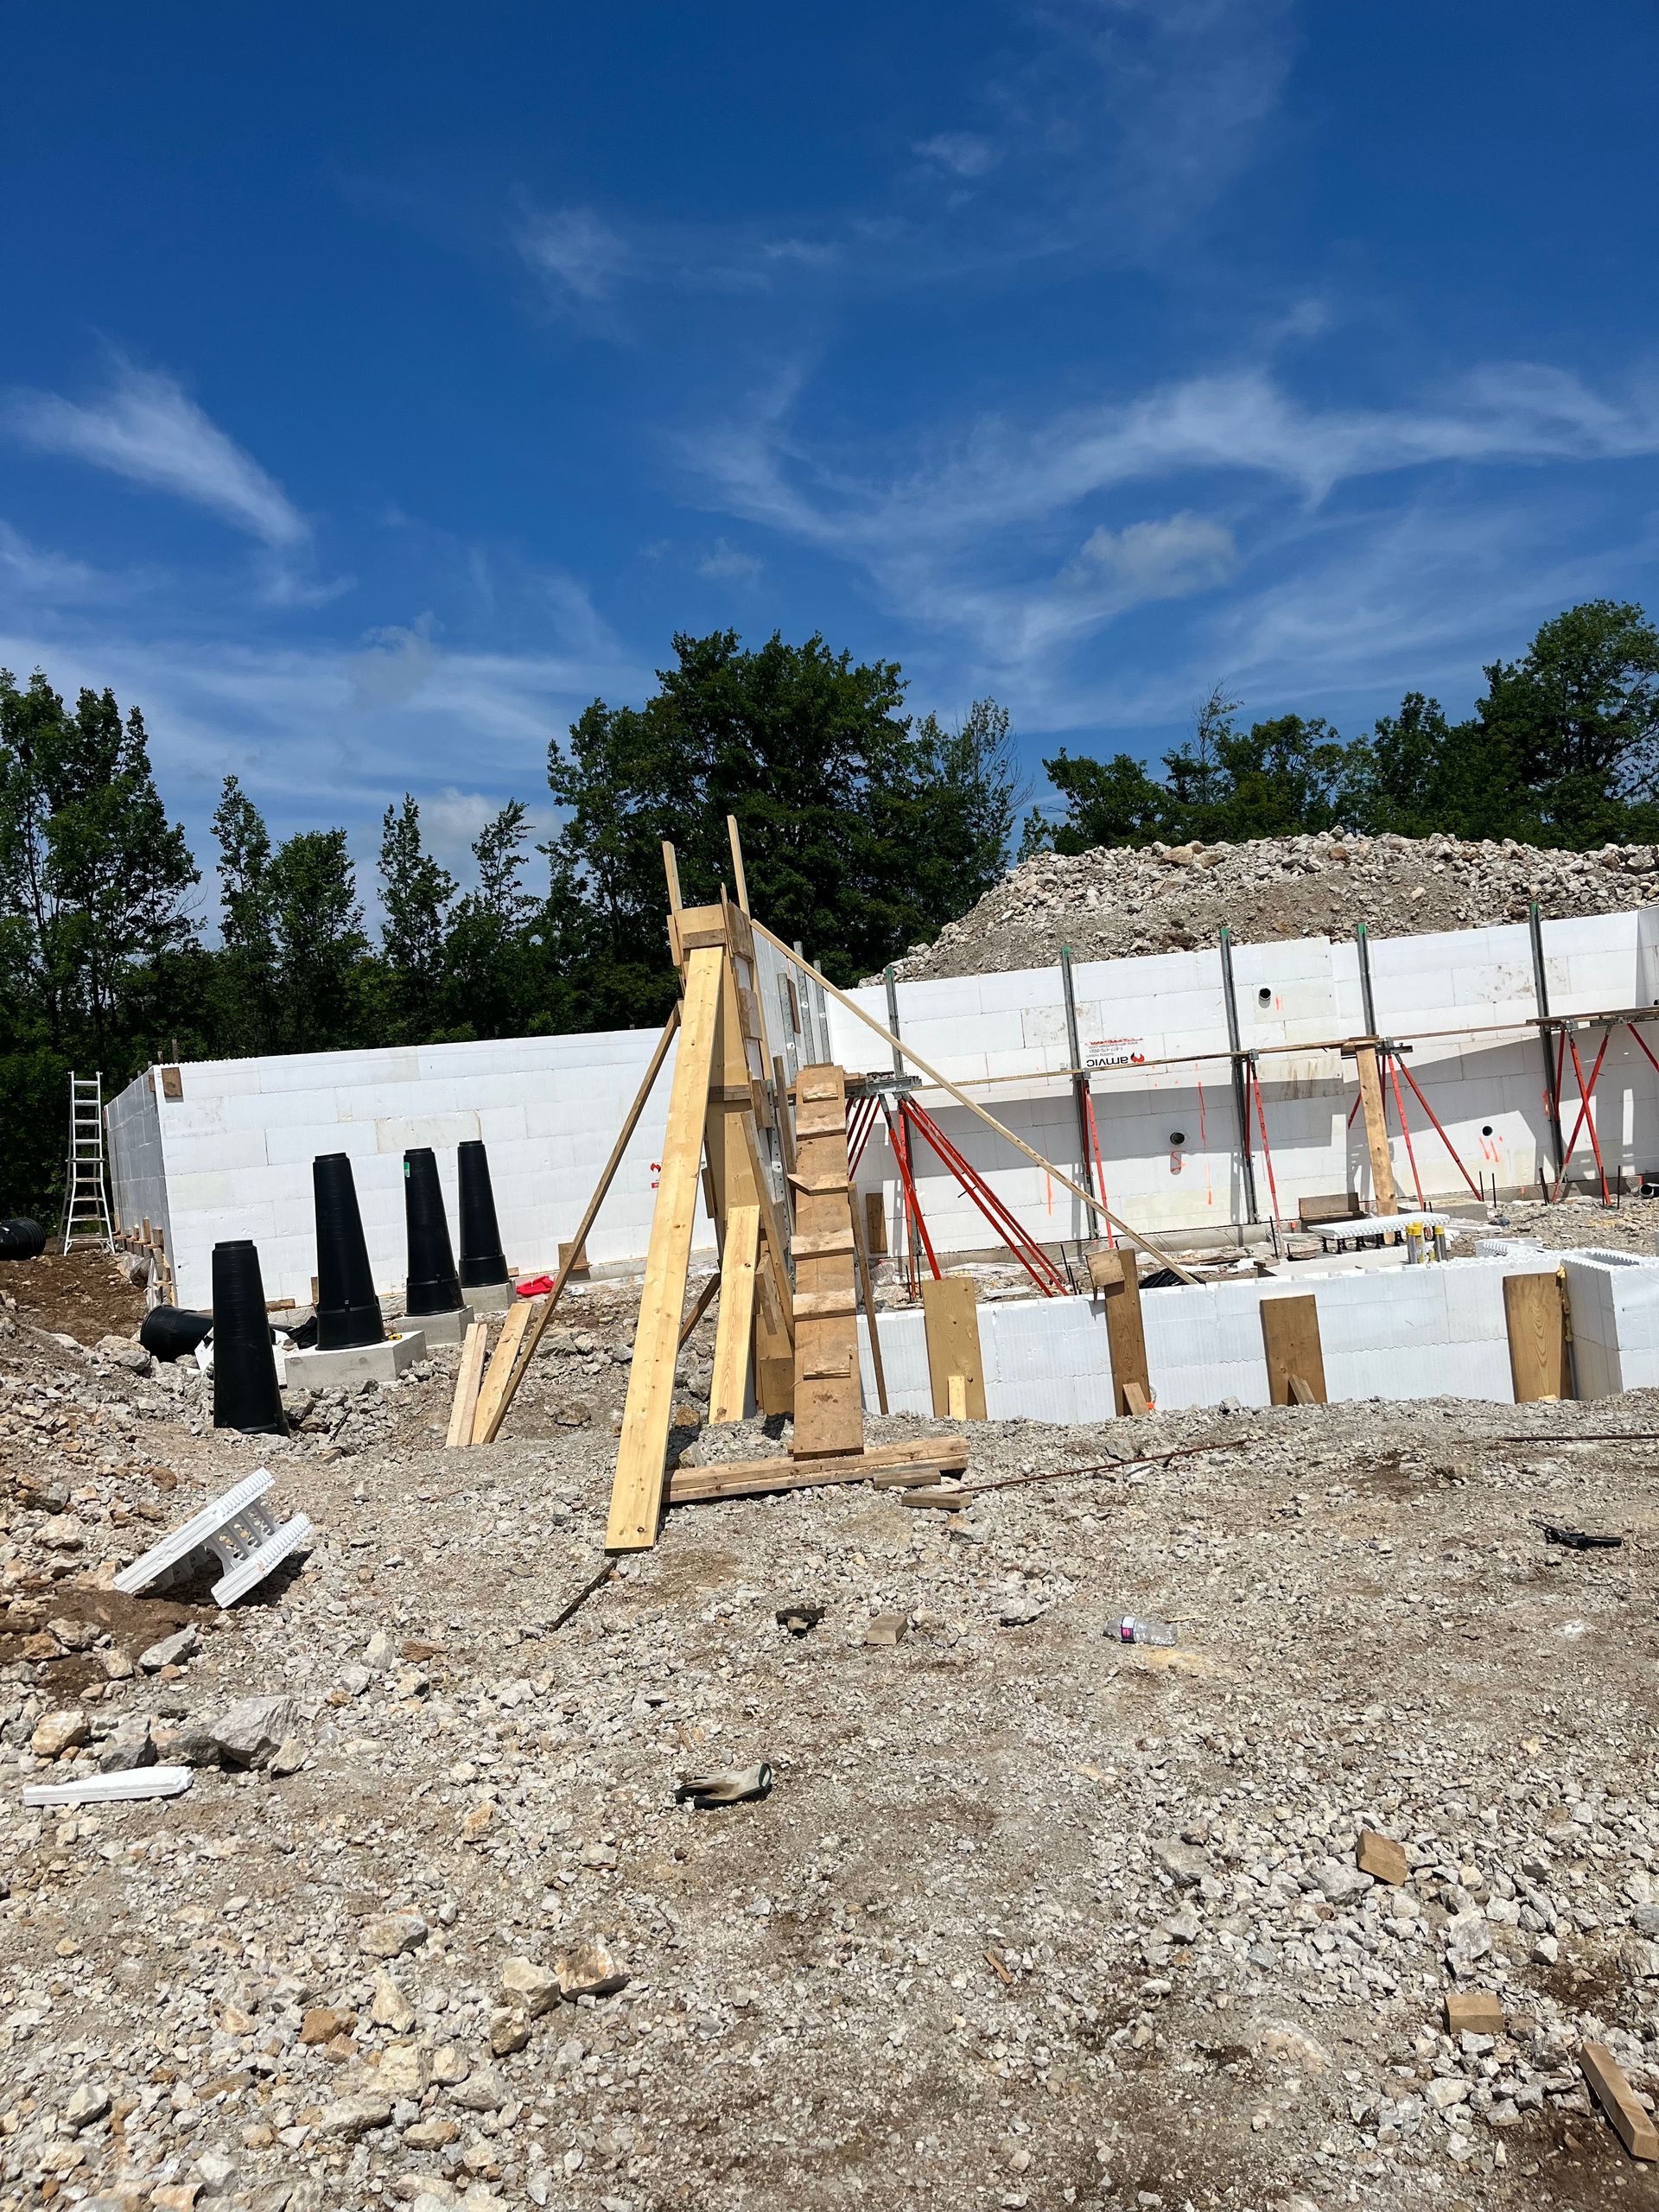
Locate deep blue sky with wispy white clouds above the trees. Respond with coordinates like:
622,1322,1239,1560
0,0,1659,889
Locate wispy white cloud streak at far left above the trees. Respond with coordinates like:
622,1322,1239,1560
4,360,309,553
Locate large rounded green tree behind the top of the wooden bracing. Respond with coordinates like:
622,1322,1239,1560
549,631,1013,1024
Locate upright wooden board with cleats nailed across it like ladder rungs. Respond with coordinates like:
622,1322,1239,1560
790,1066,865,1460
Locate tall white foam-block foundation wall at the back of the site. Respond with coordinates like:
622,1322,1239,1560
108,912,1659,1303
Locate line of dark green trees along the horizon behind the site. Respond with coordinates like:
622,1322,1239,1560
0,600,1659,1212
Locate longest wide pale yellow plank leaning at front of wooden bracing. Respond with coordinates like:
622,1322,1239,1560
606,947,726,1551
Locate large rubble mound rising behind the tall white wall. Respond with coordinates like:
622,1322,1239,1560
896,836,1659,978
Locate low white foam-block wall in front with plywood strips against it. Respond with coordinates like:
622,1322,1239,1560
858,1249,1659,1422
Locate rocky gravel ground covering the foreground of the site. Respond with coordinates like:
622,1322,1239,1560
0,1265,1659,2212
